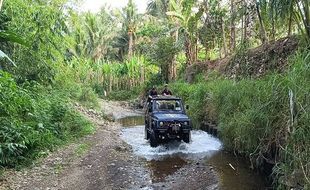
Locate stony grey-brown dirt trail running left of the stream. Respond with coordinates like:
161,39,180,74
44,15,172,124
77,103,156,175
0,101,218,190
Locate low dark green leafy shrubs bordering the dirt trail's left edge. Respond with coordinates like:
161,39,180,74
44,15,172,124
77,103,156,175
0,71,92,167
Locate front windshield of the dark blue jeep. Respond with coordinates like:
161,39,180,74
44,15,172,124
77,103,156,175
155,100,183,112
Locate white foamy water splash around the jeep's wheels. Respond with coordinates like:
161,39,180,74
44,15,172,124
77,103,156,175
121,126,222,160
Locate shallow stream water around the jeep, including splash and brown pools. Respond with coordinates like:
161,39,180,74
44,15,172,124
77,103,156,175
119,116,266,190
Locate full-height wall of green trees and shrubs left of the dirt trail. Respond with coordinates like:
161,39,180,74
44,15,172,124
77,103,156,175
0,0,97,168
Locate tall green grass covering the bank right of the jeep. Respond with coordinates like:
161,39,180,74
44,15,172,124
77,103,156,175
172,50,310,189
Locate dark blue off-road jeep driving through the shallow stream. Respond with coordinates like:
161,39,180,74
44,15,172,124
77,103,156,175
145,96,192,147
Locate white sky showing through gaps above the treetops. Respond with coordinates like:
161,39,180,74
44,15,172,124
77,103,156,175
82,0,148,13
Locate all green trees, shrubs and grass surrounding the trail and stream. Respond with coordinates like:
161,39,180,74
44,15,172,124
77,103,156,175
0,0,310,189
